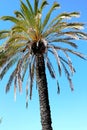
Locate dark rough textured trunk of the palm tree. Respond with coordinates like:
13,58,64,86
36,54,52,130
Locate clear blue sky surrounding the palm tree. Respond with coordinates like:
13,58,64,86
0,0,87,130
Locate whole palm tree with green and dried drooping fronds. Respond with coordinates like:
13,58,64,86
0,0,87,130
